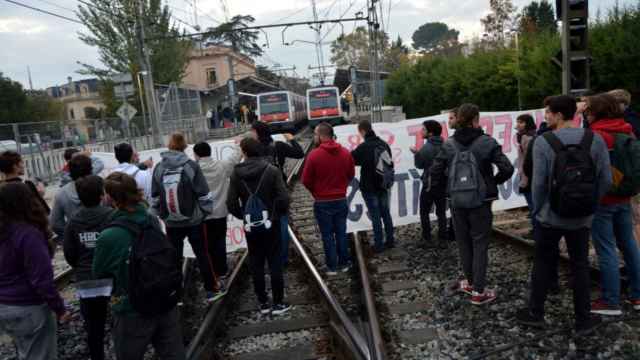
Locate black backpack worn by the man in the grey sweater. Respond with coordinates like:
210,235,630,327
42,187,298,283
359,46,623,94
542,129,598,218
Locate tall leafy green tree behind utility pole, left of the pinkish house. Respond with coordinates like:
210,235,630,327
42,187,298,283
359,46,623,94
77,0,191,84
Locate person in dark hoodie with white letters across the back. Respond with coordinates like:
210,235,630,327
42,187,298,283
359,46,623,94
63,175,114,360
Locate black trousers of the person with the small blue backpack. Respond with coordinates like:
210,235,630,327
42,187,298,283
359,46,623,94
246,226,284,304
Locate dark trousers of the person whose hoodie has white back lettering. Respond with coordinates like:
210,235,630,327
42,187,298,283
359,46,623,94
80,296,109,360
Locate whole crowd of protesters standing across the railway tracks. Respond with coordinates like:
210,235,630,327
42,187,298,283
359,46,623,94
0,90,640,360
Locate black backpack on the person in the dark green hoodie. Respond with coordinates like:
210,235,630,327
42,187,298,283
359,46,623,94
109,215,182,316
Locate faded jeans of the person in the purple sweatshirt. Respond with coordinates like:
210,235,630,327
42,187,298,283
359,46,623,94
0,304,58,360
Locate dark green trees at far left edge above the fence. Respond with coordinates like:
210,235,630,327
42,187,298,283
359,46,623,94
0,72,64,124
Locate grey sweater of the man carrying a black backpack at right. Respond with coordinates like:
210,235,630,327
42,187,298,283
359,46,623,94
531,128,612,230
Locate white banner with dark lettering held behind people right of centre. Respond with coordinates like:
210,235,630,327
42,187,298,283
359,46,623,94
334,110,556,232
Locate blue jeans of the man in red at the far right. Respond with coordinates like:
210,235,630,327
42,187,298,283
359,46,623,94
591,203,640,305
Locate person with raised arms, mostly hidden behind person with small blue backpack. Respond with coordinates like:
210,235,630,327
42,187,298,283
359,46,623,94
251,121,304,267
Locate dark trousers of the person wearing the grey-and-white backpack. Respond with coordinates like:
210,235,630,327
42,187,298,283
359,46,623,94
167,224,217,291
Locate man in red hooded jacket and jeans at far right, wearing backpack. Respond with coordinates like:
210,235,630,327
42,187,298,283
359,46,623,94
585,94,640,315
